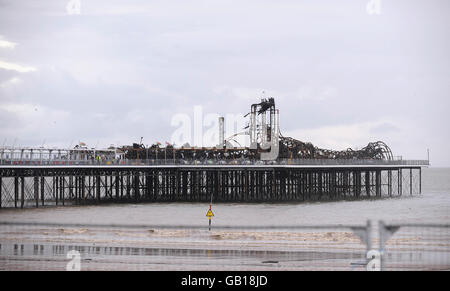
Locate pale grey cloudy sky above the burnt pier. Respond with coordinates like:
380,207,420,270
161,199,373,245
0,0,450,166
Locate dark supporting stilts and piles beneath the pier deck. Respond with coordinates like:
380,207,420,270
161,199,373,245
0,161,422,208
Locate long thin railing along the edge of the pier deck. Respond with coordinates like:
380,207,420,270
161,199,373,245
0,159,430,166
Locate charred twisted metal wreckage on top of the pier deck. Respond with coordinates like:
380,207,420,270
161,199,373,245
121,98,393,161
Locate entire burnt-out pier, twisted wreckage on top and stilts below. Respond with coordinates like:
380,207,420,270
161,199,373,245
0,98,429,208
